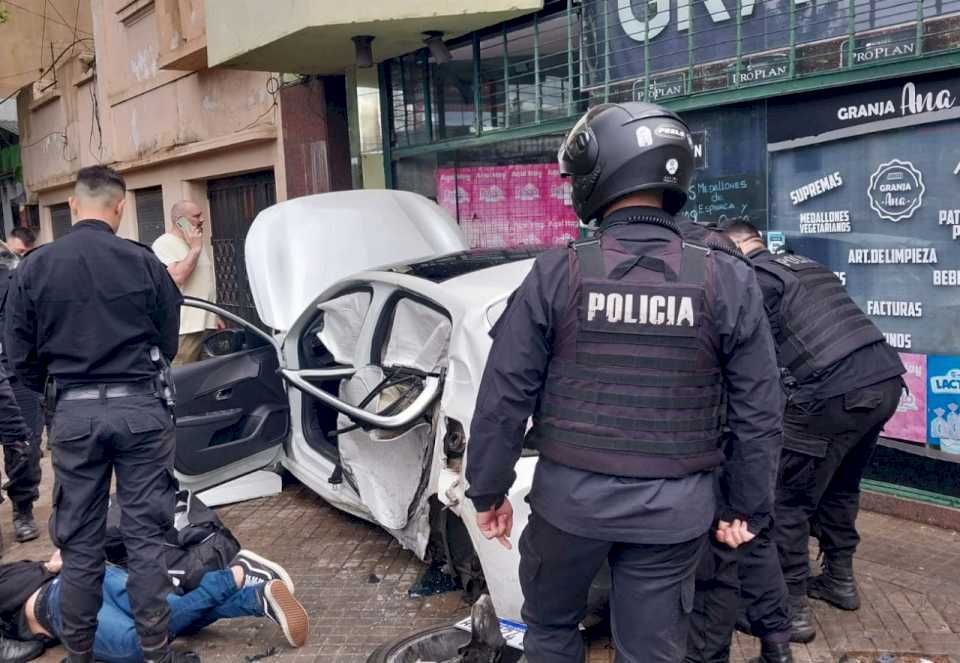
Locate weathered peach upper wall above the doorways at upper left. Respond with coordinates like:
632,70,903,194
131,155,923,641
18,0,286,240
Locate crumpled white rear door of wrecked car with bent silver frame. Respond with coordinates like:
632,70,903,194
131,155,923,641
283,288,452,549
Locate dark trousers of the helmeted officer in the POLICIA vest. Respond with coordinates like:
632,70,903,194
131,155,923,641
520,513,706,663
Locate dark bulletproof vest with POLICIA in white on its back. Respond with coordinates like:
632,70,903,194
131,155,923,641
527,220,725,478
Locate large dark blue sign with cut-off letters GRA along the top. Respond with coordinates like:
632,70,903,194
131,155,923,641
582,0,960,87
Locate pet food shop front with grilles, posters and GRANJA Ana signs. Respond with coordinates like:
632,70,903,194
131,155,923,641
380,0,960,506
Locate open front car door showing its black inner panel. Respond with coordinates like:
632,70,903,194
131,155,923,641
172,298,290,492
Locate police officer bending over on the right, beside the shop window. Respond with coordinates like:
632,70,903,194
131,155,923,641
724,223,905,639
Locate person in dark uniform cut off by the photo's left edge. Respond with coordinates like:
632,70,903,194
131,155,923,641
0,242,43,548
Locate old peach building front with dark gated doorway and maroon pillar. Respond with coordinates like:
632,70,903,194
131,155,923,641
18,0,351,324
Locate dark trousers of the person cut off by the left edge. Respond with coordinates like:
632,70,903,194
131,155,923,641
0,378,42,506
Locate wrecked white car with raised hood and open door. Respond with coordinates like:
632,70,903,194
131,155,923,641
174,191,536,620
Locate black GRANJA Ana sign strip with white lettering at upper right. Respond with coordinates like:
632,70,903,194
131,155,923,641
767,77,960,143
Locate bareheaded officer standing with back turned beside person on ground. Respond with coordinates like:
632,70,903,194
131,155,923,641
6,166,185,663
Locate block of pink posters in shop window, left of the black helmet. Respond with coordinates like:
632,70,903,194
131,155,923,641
437,164,579,248
